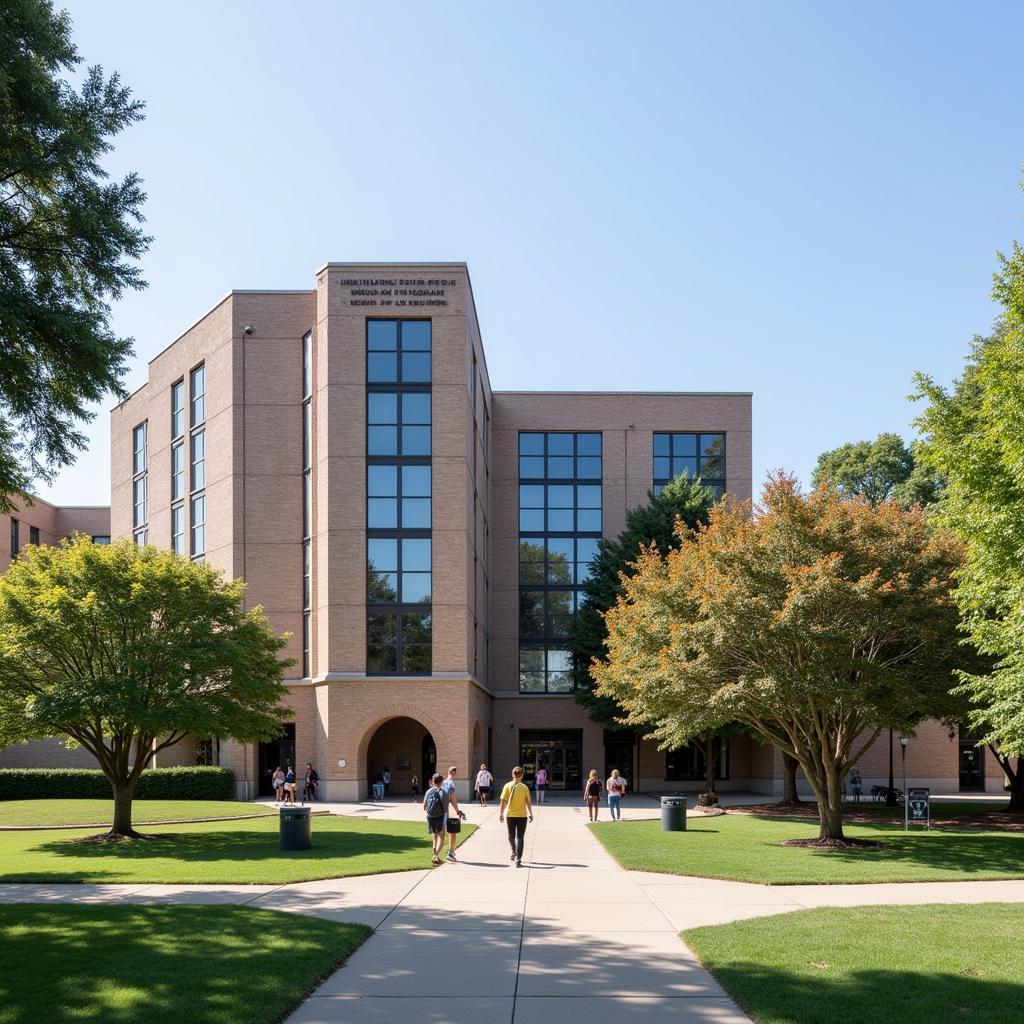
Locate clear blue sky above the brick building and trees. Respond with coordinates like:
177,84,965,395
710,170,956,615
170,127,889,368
41,0,1024,504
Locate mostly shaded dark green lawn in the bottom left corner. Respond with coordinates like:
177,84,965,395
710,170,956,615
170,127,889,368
0,904,371,1024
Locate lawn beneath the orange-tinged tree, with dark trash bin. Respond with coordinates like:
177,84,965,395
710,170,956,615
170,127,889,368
590,814,1024,885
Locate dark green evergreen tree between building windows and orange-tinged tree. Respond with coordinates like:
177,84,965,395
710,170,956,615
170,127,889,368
565,475,714,729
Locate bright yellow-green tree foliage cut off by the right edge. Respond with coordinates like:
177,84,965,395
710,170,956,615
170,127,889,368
915,235,1024,812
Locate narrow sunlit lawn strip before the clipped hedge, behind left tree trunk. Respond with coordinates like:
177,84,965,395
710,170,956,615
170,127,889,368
0,800,276,826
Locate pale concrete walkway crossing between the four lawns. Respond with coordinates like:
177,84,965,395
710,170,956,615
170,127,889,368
0,805,1024,1024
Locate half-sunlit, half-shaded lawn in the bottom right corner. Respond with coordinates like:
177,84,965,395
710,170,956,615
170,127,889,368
683,903,1024,1024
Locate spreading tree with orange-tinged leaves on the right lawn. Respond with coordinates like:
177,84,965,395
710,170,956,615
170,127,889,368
592,475,962,845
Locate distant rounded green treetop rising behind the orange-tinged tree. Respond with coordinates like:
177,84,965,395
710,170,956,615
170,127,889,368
811,433,942,508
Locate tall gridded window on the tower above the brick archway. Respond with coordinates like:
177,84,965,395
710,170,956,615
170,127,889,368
367,321,432,675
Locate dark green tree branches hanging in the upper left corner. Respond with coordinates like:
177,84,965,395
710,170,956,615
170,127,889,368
0,0,150,512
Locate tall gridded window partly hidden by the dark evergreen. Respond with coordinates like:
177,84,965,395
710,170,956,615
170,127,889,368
519,432,601,693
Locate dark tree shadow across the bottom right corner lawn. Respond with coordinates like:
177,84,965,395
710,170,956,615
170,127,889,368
700,949,1024,1024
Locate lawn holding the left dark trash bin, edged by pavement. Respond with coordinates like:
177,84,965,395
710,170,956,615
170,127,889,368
0,815,474,885
